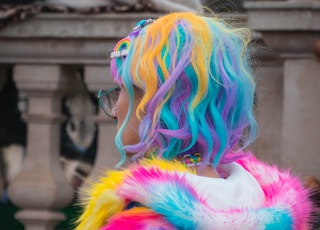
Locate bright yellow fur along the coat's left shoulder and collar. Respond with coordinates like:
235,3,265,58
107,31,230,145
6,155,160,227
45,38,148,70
76,158,192,230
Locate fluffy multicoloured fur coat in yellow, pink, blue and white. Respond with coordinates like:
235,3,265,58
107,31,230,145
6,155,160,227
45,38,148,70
76,155,312,230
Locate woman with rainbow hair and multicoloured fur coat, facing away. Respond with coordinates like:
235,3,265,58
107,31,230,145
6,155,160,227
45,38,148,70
77,13,312,230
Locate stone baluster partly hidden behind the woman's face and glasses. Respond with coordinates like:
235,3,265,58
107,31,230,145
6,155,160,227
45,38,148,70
80,65,120,195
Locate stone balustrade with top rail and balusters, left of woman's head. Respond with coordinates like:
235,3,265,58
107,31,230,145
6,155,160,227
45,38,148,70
0,13,161,230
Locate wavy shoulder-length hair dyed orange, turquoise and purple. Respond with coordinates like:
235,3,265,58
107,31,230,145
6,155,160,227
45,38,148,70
111,12,257,167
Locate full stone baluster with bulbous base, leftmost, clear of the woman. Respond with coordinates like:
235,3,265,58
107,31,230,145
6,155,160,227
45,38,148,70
9,64,74,230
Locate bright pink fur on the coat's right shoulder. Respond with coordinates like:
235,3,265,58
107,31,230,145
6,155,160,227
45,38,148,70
237,155,312,230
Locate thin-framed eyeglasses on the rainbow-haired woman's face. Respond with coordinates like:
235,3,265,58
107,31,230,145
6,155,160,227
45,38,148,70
98,86,120,119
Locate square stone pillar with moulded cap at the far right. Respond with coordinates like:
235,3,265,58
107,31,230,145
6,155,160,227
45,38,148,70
245,0,320,177
